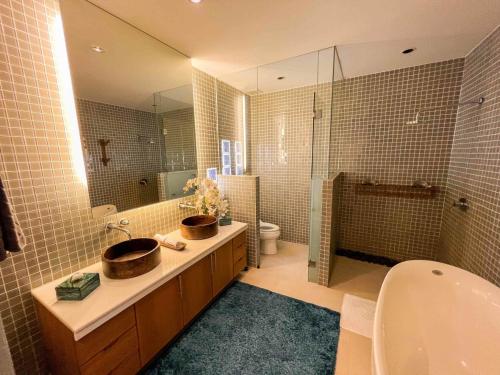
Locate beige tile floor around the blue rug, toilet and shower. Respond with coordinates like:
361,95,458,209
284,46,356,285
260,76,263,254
240,241,389,375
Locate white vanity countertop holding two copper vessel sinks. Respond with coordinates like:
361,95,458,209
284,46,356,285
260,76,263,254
31,221,248,340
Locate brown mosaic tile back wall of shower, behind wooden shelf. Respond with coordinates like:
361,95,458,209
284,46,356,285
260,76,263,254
331,59,463,260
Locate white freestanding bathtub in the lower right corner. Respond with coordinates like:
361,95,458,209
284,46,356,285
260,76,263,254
373,260,500,375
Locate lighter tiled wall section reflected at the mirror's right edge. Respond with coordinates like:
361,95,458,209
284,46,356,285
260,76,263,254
158,108,197,172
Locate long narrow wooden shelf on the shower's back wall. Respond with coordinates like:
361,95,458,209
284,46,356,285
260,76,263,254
354,184,439,199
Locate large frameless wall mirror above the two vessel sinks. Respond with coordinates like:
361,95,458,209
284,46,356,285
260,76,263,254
61,0,197,216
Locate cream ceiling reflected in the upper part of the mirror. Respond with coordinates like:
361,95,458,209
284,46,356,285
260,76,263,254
61,0,192,112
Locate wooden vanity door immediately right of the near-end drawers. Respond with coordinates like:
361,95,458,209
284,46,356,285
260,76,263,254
135,277,184,365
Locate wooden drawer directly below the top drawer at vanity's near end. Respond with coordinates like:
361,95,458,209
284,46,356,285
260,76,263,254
80,327,141,375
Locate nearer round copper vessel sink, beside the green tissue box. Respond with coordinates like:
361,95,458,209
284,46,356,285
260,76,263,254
102,238,161,279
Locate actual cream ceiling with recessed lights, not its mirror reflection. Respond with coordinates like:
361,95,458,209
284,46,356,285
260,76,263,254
91,0,500,77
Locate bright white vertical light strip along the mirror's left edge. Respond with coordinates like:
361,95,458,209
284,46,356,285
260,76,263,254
49,14,87,185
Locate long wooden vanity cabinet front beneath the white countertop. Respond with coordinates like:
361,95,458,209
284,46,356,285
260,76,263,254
35,232,247,375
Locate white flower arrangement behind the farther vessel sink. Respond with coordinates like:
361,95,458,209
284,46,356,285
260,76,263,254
183,177,229,217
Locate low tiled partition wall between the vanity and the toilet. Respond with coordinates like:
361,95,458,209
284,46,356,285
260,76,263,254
218,175,260,267
